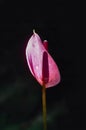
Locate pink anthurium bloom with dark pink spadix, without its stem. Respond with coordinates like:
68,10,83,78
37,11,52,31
26,31,60,88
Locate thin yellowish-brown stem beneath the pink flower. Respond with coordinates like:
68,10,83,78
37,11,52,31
42,85,47,130
